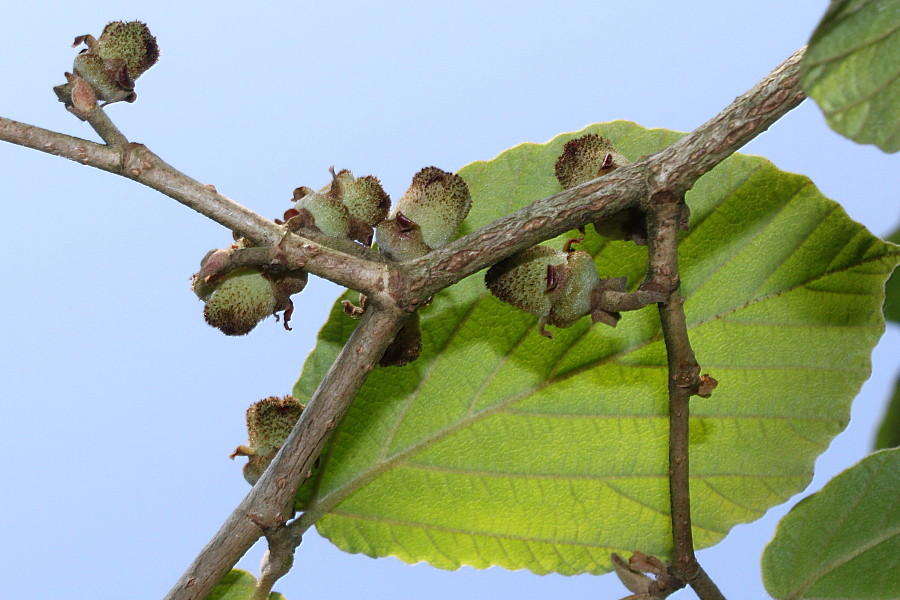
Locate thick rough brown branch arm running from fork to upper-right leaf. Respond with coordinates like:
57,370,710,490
404,49,806,298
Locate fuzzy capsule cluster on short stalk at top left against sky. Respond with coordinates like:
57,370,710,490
53,21,159,119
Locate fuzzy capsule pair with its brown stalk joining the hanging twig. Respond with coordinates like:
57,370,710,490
484,238,666,339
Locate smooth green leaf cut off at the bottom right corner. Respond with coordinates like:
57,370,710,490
762,450,900,600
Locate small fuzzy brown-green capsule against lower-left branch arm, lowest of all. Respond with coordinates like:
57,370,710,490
231,396,306,485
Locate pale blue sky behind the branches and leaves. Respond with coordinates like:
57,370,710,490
0,0,900,600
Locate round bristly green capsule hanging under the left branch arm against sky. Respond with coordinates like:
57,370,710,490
195,267,278,335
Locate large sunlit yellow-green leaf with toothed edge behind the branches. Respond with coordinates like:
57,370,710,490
295,121,898,574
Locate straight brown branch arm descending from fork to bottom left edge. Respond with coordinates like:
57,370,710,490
166,304,409,600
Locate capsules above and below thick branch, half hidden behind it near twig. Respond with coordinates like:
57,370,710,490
554,133,647,246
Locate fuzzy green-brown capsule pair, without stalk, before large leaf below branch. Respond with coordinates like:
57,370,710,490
485,244,600,337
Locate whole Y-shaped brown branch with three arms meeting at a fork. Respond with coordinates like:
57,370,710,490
0,45,805,600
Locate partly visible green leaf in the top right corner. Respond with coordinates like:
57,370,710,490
801,0,900,152
